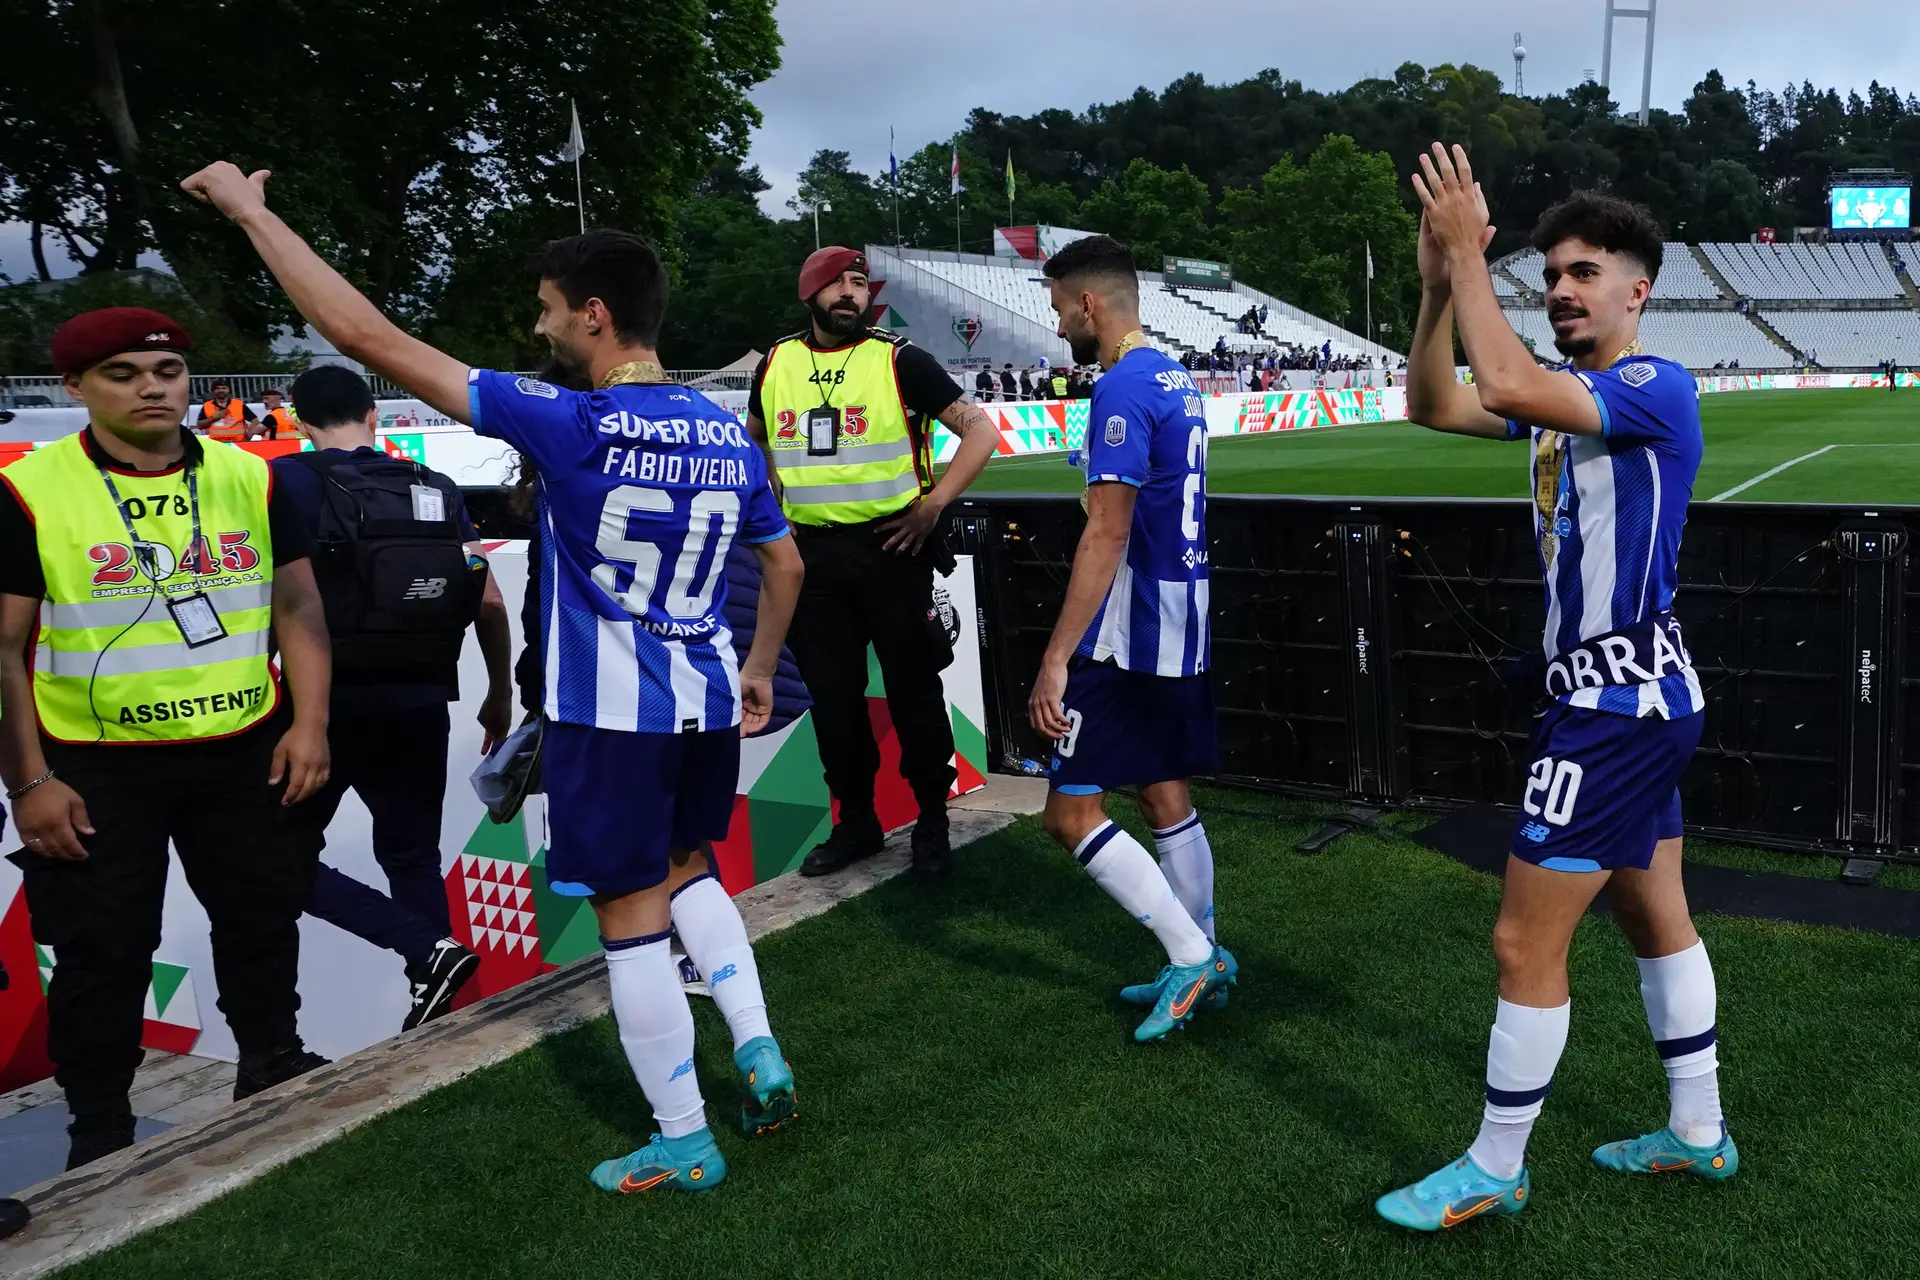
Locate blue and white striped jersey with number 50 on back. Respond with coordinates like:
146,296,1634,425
468,368,787,733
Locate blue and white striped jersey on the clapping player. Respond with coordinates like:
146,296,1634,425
1507,355,1707,720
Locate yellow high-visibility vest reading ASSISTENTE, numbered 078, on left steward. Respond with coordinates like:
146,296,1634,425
0,432,278,743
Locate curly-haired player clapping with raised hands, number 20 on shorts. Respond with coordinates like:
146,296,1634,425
1377,144,1740,1230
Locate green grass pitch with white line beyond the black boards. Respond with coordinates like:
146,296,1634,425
973,390,1920,505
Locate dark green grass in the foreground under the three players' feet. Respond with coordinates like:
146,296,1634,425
65,793,1920,1280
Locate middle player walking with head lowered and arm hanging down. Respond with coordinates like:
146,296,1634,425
1027,236,1238,1042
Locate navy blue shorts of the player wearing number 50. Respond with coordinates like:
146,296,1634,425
540,720,739,898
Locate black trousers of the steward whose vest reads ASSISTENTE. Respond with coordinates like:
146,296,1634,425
17,716,313,1119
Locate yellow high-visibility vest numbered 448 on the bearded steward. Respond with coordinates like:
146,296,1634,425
760,328,933,524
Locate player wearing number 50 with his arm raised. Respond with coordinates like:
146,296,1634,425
182,161,801,1192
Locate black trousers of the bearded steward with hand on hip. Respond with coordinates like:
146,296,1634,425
787,524,954,816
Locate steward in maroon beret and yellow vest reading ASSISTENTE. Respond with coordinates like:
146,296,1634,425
0,307,328,1169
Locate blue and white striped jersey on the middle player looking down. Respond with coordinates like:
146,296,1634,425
1077,347,1213,676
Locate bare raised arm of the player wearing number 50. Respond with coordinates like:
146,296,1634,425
180,159,468,422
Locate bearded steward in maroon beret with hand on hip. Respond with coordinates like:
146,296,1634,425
747,246,995,879
